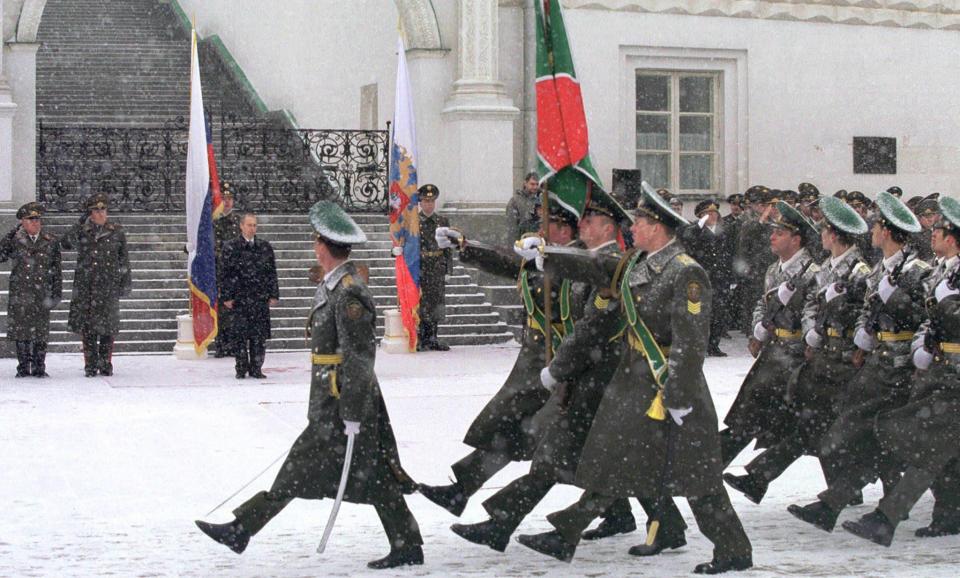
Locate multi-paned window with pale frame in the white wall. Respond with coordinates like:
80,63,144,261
636,70,722,193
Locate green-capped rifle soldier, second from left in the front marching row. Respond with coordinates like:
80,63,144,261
723,197,870,504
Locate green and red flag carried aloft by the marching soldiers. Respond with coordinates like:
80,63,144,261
534,0,603,217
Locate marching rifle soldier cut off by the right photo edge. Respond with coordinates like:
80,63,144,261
843,197,960,546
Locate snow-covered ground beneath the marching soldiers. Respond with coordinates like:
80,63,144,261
0,340,960,577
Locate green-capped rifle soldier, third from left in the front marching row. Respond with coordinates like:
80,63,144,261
788,191,931,532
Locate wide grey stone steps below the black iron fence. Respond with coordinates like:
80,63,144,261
0,215,513,353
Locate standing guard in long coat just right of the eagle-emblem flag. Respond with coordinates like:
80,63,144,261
417,185,453,351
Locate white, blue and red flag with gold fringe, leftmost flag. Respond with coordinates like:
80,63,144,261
186,30,220,353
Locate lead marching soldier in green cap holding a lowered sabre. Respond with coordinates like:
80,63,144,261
196,201,423,569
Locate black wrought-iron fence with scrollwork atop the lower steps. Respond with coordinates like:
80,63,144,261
37,116,389,213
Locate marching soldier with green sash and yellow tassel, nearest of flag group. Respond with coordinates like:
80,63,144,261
518,189,753,574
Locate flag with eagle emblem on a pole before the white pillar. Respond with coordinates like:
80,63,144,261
390,38,420,351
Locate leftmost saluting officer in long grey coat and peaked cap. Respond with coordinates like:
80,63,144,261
0,202,63,377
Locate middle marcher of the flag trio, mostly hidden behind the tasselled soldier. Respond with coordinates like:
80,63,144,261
450,197,636,552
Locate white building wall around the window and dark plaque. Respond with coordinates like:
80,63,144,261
565,9,960,196
